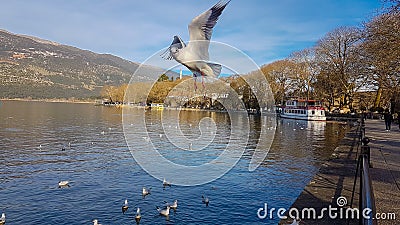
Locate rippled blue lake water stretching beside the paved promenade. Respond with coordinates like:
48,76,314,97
0,101,348,225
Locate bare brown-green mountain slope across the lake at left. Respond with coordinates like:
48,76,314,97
0,30,170,98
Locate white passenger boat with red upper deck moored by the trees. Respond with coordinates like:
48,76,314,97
280,99,326,121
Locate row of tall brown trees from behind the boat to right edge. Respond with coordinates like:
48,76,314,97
261,0,400,110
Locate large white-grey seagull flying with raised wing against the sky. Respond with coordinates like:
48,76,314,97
163,0,230,88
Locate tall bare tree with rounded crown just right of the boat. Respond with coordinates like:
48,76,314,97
316,27,365,109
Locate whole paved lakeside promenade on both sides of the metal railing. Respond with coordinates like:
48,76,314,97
279,120,400,225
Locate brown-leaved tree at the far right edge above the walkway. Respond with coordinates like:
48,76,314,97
363,7,400,107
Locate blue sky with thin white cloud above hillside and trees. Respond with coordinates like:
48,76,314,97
0,0,382,65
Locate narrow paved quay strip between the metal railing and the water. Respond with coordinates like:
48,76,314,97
278,126,359,225
